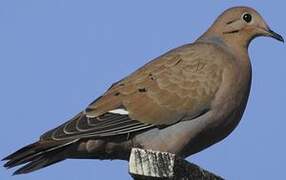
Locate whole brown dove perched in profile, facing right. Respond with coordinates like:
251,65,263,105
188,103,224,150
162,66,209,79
3,7,284,174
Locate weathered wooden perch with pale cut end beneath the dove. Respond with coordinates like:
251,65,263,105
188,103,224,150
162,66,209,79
129,148,223,180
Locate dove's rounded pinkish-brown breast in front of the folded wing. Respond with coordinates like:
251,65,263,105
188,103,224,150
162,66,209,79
209,54,251,134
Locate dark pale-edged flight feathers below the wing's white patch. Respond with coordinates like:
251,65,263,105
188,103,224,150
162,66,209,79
41,112,154,140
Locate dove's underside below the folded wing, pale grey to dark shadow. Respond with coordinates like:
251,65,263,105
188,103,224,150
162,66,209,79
152,83,250,157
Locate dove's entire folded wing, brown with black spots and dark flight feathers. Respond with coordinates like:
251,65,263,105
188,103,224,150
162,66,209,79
41,43,227,140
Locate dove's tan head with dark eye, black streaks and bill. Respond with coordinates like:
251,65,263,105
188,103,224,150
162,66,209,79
199,7,284,47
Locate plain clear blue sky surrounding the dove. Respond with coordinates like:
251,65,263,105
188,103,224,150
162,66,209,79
0,0,286,180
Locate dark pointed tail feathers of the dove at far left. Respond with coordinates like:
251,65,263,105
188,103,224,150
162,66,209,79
3,140,77,175
